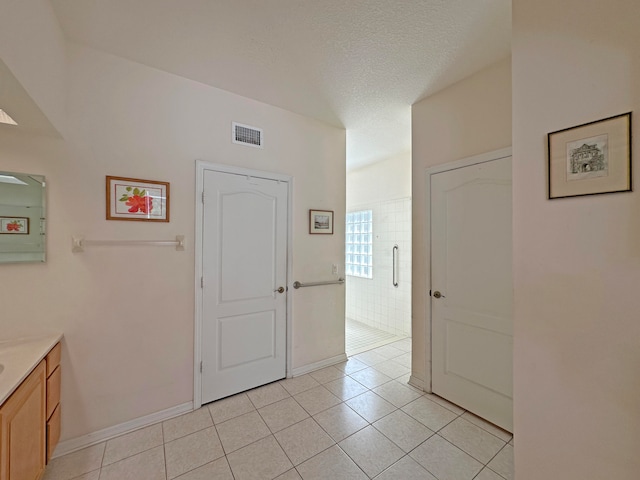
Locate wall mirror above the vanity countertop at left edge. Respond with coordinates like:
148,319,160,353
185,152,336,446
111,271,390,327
0,172,46,263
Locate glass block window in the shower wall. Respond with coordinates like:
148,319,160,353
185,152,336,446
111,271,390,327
345,210,373,278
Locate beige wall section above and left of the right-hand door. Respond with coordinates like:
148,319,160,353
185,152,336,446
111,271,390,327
412,58,511,389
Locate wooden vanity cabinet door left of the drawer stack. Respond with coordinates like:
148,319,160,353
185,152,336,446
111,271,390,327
0,360,47,480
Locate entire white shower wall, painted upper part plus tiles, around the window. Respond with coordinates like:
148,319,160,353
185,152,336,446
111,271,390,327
346,152,411,336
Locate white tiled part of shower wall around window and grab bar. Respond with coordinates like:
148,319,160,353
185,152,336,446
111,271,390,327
346,198,411,336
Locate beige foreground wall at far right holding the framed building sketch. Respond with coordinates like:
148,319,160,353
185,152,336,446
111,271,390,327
513,0,640,480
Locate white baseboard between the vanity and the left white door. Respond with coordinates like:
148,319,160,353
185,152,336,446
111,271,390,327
52,402,193,458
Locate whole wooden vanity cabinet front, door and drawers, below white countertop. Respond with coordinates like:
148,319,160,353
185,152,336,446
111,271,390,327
0,343,60,480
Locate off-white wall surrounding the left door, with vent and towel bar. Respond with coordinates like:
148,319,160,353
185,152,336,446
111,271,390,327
0,45,345,440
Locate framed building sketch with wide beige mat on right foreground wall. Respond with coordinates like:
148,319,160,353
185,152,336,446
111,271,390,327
547,112,631,199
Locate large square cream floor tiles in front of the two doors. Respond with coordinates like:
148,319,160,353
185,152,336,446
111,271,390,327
44,339,513,480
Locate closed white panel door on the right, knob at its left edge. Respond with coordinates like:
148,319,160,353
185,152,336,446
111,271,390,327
431,157,513,431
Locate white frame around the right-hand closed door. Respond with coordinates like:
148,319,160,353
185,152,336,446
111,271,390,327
423,147,512,393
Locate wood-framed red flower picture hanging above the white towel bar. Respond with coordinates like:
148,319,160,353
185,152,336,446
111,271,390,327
107,176,169,222
